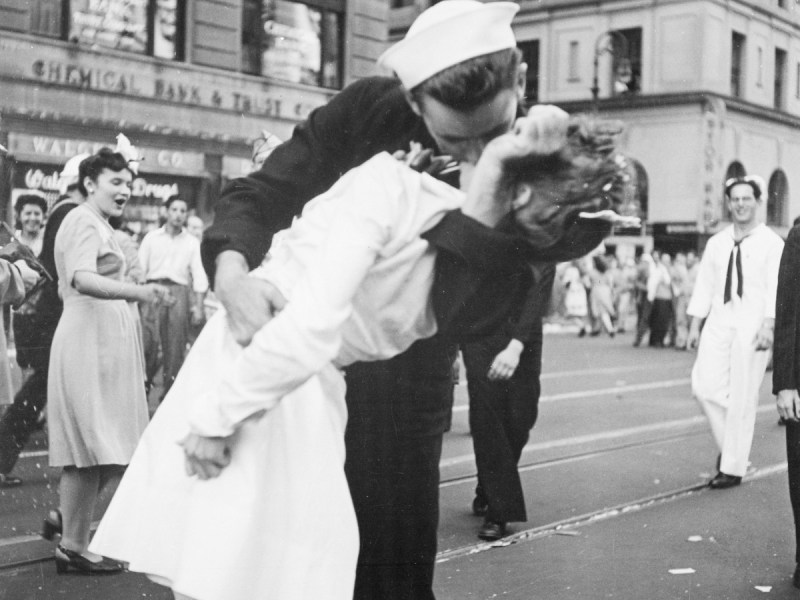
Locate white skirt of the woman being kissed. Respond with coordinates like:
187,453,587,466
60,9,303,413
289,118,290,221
91,312,358,600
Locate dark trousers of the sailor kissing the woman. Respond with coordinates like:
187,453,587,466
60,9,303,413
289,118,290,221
345,337,455,600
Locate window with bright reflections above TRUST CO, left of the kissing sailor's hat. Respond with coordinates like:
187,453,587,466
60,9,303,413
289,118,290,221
242,0,345,88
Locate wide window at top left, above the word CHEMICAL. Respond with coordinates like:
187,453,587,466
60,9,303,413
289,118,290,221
0,0,186,60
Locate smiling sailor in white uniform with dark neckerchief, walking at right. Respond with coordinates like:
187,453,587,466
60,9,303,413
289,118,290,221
687,177,783,489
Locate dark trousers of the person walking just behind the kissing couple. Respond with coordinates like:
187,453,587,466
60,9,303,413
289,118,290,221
461,326,542,522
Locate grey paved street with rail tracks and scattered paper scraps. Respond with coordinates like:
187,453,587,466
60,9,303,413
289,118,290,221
0,334,800,600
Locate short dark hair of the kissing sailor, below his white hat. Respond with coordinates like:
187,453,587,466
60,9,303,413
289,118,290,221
411,48,522,110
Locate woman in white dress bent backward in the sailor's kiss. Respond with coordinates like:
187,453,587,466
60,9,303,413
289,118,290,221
91,109,636,600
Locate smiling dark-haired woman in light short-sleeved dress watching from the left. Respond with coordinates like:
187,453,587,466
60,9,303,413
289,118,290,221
43,148,168,573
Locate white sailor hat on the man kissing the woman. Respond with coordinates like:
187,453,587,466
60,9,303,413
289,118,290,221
378,0,519,90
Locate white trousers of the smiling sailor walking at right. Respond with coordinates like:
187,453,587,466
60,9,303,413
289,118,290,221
692,311,770,477
